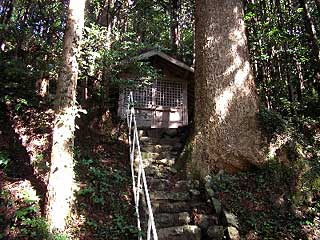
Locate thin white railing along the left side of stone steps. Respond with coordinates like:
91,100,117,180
127,92,158,240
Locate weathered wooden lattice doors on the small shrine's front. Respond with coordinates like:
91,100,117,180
122,79,188,128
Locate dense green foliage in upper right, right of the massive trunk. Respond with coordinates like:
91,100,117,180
245,1,320,109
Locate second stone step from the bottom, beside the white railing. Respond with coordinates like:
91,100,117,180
155,212,191,228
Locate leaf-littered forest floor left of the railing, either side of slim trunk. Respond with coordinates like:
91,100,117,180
0,81,138,240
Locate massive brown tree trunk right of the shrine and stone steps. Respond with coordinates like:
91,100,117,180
192,0,263,175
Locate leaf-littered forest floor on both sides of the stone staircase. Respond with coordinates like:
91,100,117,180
0,80,320,240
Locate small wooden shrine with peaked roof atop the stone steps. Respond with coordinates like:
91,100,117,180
118,50,194,128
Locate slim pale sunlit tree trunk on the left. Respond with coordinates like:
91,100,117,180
47,0,85,232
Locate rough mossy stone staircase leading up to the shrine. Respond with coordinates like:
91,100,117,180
140,130,224,240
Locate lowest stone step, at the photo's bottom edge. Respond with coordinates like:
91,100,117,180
158,225,201,240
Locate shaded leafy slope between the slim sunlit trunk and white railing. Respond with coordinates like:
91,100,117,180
72,116,138,240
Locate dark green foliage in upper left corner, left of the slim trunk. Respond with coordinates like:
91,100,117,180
0,1,65,94
